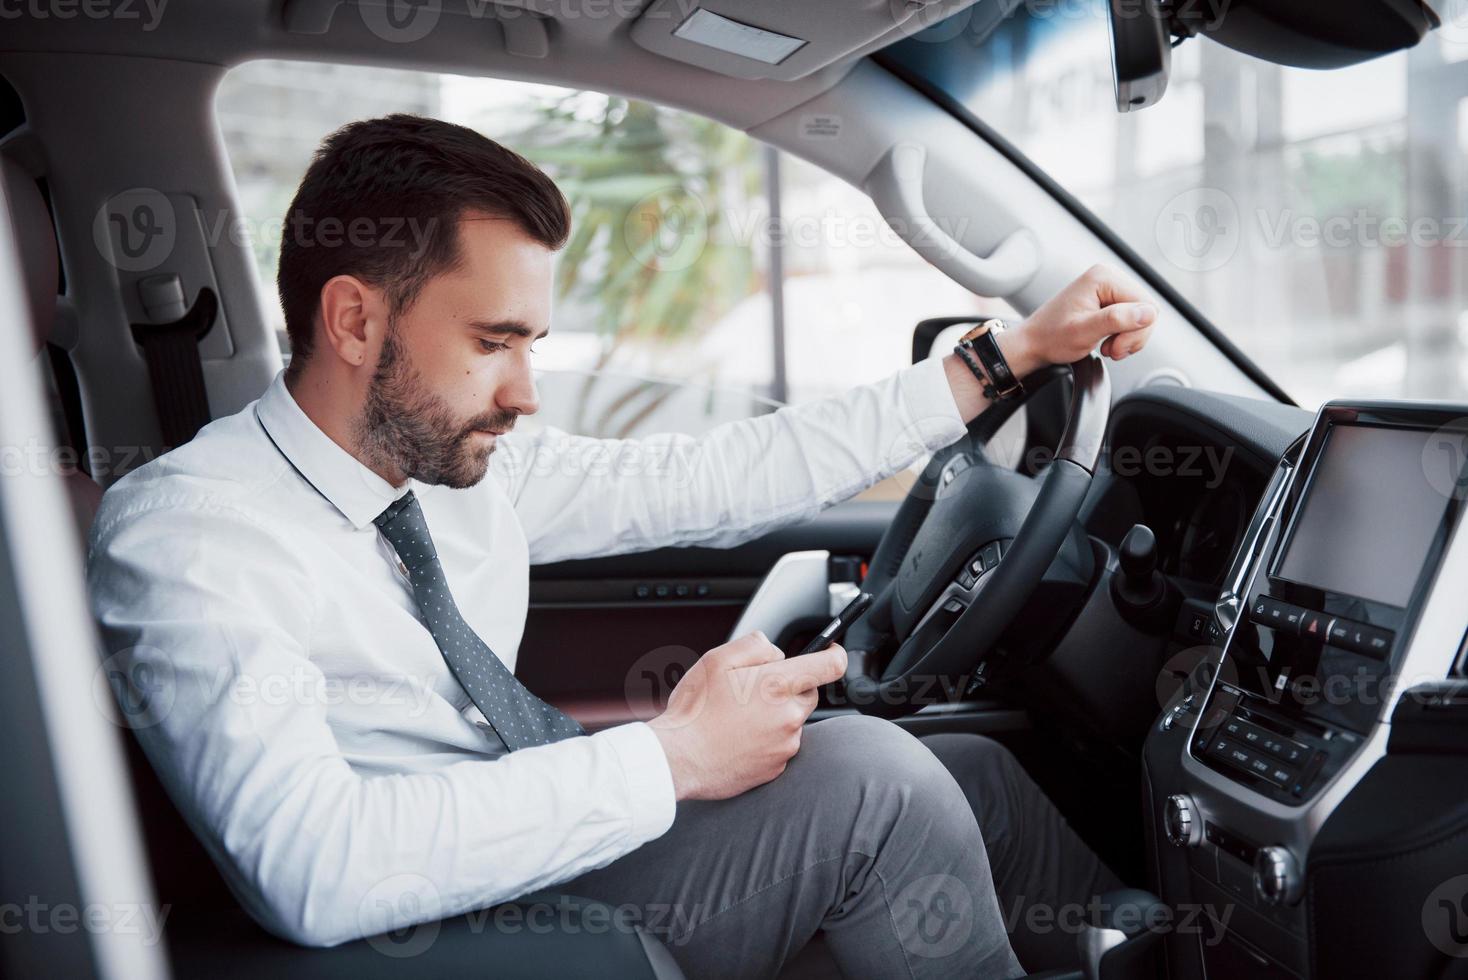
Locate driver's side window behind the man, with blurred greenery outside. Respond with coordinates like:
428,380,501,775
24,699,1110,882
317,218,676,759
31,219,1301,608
217,62,1004,496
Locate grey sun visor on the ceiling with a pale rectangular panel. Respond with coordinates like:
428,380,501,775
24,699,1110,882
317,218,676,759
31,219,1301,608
631,0,973,81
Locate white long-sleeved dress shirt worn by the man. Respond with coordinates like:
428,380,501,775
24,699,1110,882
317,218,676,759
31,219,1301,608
88,359,963,945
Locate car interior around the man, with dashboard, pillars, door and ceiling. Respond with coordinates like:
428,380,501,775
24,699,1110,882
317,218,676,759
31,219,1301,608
0,0,1468,980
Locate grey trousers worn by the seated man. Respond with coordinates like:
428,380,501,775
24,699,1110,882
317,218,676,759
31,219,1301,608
556,716,1117,980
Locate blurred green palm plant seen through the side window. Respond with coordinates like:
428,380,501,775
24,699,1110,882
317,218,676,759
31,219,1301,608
508,92,763,436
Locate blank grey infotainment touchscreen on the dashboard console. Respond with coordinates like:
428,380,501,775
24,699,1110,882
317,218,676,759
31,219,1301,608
1276,423,1450,607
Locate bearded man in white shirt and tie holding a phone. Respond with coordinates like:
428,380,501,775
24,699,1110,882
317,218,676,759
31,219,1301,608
90,116,1155,977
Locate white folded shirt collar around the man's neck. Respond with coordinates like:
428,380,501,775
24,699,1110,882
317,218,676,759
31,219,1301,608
255,371,411,530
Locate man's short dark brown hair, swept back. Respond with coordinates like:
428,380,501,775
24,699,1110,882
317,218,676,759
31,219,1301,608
276,113,571,373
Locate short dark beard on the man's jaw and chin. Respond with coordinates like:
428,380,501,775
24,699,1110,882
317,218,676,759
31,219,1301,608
354,323,520,490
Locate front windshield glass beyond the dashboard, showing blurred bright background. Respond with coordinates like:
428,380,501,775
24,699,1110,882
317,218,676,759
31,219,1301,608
888,0,1468,408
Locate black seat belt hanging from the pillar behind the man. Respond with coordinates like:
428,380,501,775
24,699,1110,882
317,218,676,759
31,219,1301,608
132,273,219,450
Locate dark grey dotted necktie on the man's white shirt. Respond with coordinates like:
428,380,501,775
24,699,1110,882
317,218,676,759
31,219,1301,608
373,490,586,751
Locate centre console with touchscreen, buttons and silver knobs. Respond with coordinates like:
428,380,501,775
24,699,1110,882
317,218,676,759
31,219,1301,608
1147,403,1468,977
